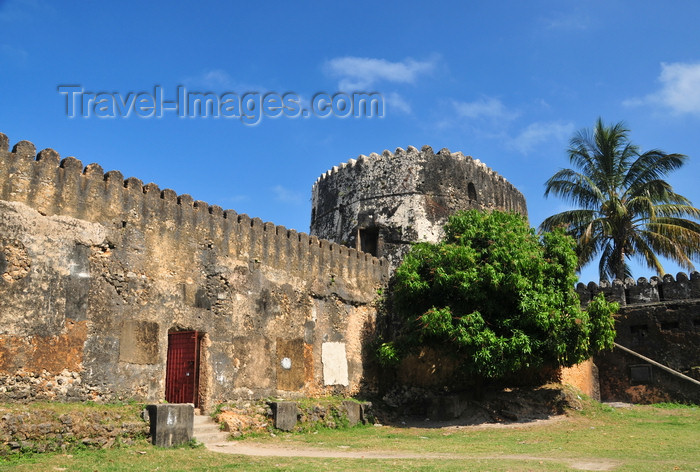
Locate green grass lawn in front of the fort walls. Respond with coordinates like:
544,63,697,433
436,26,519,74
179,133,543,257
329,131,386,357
0,404,700,472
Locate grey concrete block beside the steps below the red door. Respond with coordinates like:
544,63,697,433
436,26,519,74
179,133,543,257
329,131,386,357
146,403,194,447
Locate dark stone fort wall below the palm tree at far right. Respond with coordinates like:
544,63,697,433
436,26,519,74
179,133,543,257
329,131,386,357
576,272,700,403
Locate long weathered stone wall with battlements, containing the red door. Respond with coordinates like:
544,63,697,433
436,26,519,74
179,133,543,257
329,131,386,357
0,134,388,408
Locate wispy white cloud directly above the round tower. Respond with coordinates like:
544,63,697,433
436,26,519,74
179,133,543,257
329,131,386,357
323,56,436,92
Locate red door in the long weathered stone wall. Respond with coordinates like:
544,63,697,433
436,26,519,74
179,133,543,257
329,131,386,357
165,331,199,407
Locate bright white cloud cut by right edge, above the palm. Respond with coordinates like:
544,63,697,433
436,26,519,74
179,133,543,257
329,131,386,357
623,62,700,115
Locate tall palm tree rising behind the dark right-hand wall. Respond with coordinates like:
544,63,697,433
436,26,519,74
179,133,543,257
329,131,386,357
540,118,700,279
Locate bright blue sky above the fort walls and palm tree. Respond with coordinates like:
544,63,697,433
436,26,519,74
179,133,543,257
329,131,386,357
0,0,700,281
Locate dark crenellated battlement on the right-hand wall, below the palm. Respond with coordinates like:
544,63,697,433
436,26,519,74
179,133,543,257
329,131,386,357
576,271,700,306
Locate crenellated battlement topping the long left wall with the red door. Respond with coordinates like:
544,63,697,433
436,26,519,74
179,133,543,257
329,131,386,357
0,133,388,283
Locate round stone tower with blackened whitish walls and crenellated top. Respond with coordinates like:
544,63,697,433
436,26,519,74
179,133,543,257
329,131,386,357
310,146,527,269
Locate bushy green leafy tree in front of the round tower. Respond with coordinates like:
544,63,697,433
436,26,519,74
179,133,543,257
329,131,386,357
378,210,618,379
